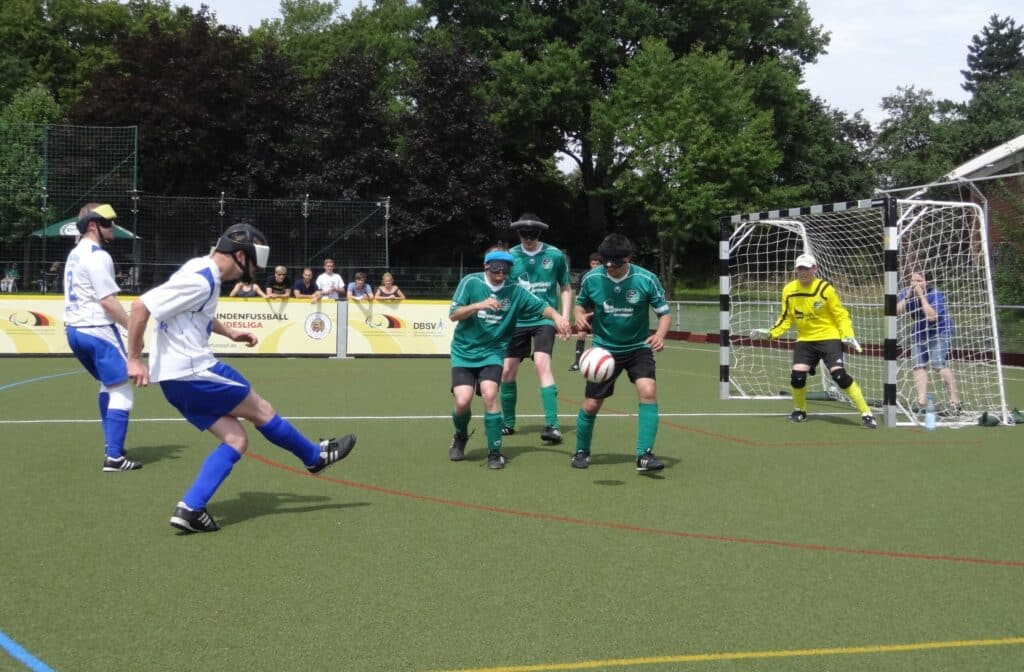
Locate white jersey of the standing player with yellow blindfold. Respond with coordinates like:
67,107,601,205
65,238,121,327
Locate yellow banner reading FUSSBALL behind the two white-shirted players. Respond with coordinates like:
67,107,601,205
0,294,338,356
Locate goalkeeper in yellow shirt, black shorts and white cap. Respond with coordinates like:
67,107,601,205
751,254,878,429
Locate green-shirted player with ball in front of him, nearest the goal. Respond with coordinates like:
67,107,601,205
571,234,672,472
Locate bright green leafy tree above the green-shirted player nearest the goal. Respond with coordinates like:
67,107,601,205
594,40,781,288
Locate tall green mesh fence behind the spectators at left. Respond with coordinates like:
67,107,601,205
0,125,389,291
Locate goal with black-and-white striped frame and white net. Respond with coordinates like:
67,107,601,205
719,197,1012,426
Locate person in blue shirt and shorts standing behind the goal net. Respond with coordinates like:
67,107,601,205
896,270,962,413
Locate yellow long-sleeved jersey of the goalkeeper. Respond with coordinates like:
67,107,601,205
771,278,853,341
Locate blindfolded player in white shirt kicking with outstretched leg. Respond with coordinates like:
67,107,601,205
128,223,355,533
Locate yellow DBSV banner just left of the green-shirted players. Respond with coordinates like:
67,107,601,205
348,299,455,355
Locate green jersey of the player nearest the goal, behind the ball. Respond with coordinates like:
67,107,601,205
575,263,670,352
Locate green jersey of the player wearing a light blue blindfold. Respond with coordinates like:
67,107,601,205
449,272,548,368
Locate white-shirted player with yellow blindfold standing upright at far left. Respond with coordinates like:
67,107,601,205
65,203,142,471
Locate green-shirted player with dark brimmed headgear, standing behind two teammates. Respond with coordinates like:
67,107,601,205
501,212,572,444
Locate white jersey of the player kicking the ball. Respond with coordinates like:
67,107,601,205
139,257,220,382
